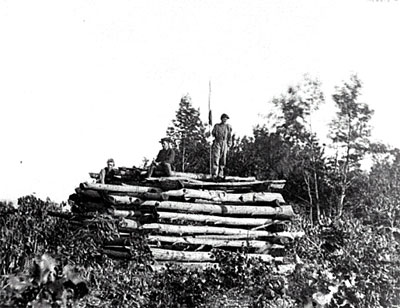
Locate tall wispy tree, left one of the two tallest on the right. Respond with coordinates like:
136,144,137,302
270,75,325,219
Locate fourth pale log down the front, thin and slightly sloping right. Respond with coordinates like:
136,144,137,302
142,223,296,238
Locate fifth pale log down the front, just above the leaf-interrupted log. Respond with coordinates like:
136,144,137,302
148,235,284,252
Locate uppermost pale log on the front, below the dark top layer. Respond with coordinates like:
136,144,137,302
162,188,285,205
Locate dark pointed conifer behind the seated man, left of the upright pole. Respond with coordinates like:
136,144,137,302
167,94,209,173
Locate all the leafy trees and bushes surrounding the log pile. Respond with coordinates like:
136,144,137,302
0,76,400,308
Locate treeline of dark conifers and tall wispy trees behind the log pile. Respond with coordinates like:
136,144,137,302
167,75,399,222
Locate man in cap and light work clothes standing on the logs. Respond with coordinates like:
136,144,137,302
212,113,232,179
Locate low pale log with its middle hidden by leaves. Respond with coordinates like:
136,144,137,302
150,247,283,263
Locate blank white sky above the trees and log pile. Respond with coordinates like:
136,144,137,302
0,0,400,201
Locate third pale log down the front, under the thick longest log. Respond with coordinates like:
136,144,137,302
158,211,282,227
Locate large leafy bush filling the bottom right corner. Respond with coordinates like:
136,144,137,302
288,215,400,308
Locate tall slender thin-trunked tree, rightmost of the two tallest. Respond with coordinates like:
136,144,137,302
330,75,373,216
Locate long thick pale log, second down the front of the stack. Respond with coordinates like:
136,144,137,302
143,200,294,219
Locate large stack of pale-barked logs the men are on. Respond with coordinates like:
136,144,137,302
61,168,301,267
